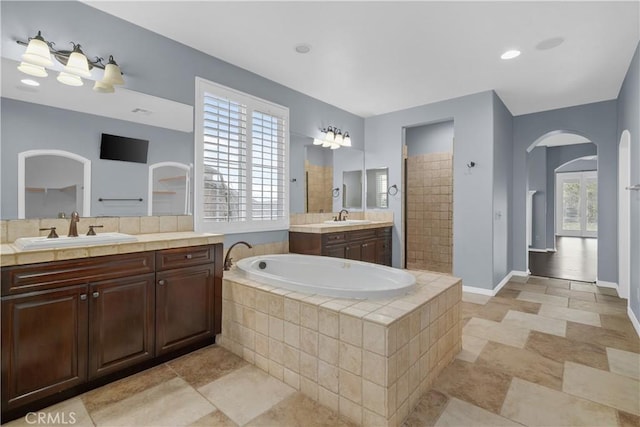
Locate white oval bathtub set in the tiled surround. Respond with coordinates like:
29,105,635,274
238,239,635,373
237,254,416,299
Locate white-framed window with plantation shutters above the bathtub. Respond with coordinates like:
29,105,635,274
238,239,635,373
195,78,289,233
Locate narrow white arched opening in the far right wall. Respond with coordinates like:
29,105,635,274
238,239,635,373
618,130,631,299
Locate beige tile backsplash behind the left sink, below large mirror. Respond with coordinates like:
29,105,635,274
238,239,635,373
0,215,193,243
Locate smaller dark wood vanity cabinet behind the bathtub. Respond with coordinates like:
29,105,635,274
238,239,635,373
289,227,391,266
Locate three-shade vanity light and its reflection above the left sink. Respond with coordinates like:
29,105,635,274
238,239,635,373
17,31,124,93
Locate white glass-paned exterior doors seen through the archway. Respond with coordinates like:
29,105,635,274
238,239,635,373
556,171,598,237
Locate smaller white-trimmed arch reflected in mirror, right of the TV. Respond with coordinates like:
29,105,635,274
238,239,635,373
148,162,191,215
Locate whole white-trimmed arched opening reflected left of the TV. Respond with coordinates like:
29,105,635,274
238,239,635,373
18,150,91,219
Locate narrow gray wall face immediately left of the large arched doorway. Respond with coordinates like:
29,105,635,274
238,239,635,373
493,93,513,286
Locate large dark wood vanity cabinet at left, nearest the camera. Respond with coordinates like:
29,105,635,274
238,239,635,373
1,244,222,415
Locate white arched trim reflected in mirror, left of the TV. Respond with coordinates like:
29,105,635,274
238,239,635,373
18,149,91,219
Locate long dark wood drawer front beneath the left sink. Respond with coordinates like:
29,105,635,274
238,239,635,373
2,252,155,296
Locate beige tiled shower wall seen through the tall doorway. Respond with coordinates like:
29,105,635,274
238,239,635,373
407,152,453,273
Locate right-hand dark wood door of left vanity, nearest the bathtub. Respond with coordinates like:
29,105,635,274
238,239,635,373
156,264,214,355
